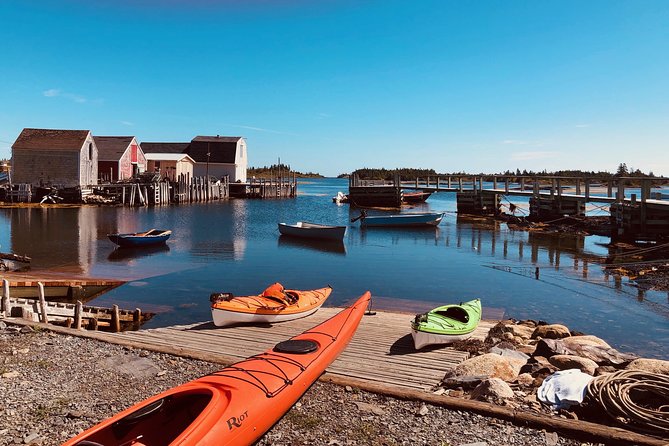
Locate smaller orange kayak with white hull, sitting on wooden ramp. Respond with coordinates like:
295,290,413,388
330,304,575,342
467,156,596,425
209,282,332,327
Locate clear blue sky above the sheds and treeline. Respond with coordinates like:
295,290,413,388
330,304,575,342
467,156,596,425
0,0,669,176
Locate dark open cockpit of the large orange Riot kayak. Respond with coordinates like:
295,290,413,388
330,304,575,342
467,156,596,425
76,389,213,446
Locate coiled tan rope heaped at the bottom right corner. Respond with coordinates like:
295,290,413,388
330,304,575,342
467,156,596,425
587,370,669,437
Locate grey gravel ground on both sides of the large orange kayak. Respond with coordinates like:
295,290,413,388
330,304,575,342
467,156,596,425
0,321,608,446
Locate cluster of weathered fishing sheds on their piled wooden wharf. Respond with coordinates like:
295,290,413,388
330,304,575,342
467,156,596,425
0,128,297,206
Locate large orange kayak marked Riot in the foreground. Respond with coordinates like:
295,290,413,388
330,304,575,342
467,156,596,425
64,291,371,446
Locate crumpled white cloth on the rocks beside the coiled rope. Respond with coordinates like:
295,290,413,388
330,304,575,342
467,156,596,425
537,369,593,409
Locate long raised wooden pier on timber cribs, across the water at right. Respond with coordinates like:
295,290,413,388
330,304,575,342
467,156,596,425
348,175,669,240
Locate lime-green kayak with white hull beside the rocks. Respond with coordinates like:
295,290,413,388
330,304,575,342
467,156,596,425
411,299,481,350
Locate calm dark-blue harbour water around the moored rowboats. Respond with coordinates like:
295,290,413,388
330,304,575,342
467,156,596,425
0,179,669,359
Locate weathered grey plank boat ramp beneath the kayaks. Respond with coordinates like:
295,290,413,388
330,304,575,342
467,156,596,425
109,308,495,390
